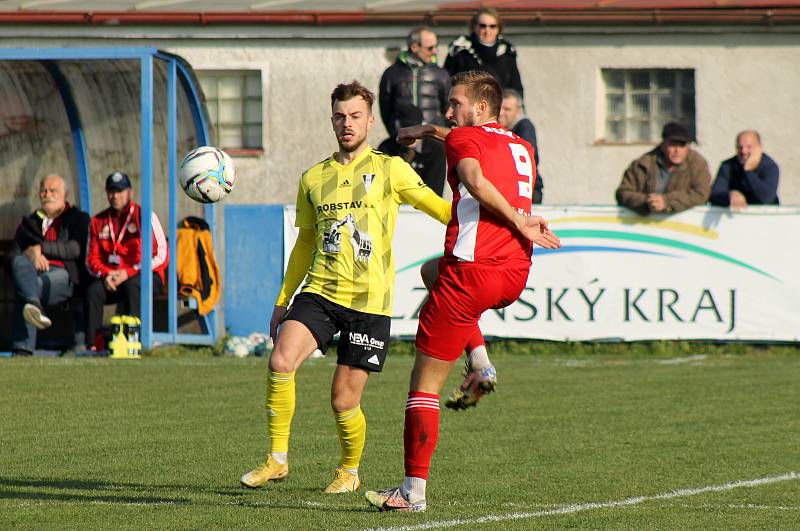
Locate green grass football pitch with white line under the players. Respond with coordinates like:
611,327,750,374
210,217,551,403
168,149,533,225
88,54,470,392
0,345,800,530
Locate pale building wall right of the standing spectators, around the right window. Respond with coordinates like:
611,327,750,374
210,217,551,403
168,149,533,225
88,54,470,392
514,32,800,204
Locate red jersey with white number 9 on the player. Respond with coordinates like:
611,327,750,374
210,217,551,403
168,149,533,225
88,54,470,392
444,122,536,265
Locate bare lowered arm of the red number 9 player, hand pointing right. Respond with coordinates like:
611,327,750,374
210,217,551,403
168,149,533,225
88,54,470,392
456,158,561,249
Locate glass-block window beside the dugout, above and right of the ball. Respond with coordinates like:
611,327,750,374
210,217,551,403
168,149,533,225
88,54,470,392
197,70,263,150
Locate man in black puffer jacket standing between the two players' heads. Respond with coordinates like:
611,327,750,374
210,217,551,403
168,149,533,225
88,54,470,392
378,27,450,195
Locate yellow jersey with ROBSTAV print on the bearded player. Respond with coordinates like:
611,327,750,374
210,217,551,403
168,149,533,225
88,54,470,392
278,147,451,316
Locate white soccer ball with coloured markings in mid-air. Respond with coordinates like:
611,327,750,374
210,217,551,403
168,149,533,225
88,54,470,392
178,146,236,203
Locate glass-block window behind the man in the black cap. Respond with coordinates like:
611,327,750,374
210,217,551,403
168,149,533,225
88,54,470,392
602,68,695,144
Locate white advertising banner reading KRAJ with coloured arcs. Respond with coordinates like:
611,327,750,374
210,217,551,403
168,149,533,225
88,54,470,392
284,206,800,341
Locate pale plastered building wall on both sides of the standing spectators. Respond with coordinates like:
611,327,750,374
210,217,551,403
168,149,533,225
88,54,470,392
0,28,800,204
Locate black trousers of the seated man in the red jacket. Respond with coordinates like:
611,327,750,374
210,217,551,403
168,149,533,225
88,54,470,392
84,273,164,345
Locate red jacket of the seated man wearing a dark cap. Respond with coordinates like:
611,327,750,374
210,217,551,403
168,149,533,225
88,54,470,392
86,201,169,281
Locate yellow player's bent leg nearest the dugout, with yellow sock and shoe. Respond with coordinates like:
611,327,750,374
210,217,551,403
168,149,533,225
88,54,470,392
239,320,318,488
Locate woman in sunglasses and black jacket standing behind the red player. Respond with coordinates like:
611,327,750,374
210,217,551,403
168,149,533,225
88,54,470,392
444,7,524,95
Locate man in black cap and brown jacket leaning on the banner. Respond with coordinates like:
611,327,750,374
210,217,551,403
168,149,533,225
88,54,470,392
616,122,711,214
